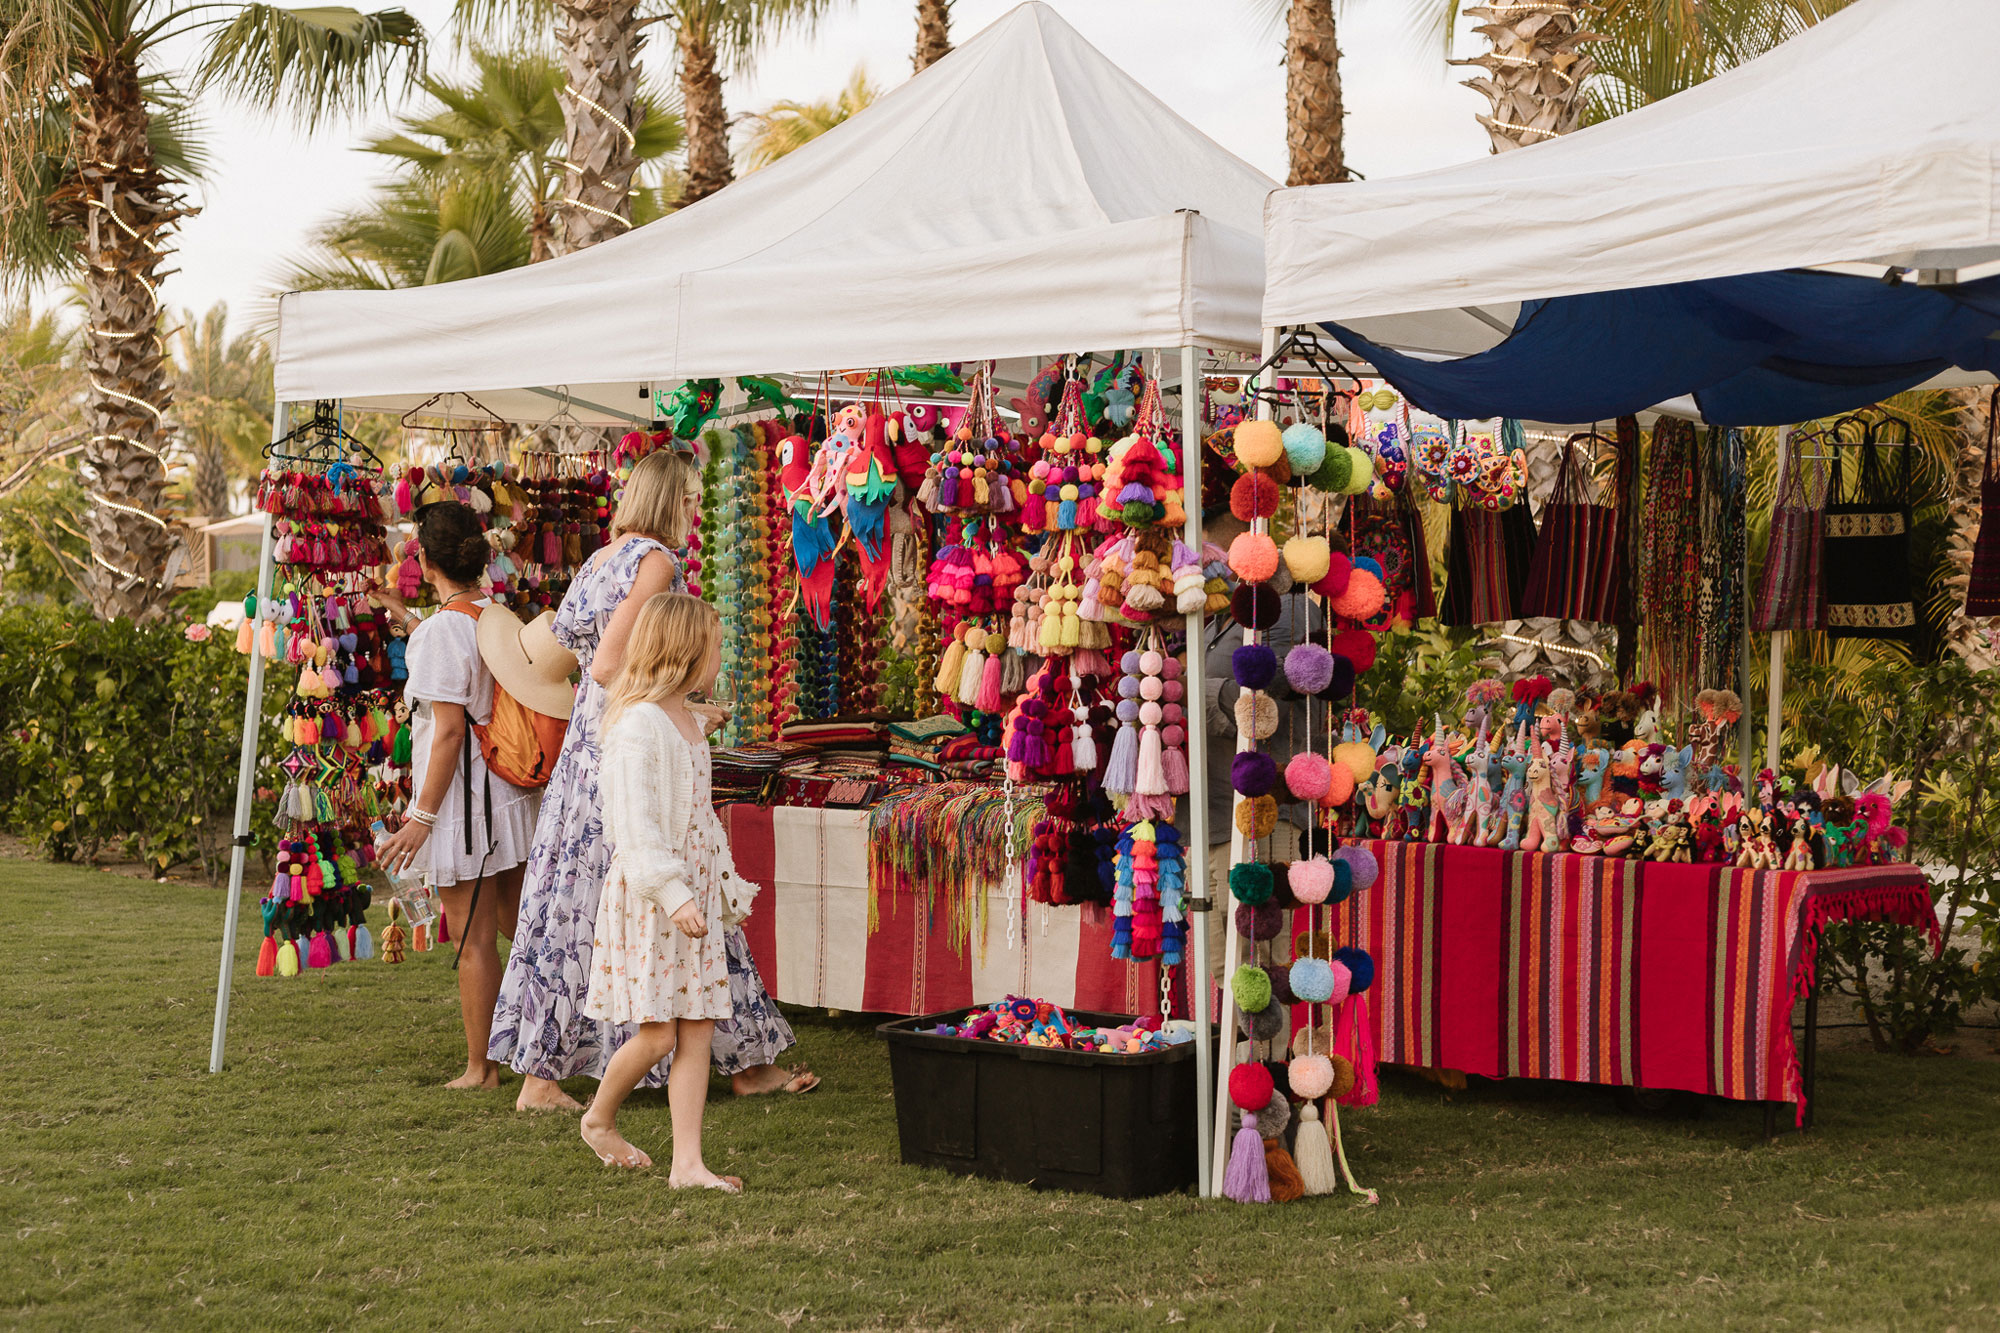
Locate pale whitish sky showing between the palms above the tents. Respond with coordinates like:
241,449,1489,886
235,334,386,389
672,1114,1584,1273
162,0,1486,328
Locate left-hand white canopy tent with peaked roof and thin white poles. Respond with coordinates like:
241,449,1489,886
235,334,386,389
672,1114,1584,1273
210,2,1276,1181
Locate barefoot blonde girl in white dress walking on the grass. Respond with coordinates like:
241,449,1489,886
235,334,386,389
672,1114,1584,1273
582,592,756,1193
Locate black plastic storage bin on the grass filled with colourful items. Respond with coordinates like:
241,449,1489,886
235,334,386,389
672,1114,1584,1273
876,1009,1194,1199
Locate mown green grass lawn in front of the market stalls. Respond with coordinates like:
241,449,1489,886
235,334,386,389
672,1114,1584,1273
0,861,2000,1329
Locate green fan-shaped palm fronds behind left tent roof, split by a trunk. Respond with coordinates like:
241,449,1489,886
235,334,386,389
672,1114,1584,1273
366,46,682,260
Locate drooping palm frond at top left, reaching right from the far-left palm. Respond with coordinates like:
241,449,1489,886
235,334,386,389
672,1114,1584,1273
196,4,424,128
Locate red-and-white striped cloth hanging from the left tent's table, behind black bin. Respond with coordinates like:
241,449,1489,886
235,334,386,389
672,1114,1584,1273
720,805,1160,1015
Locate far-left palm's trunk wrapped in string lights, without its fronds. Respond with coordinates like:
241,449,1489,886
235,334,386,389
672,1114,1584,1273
50,56,194,620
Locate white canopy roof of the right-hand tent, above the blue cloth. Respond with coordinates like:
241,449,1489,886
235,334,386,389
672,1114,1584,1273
1264,0,2000,368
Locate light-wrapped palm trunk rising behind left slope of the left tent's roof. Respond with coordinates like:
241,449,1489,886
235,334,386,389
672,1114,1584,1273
548,0,644,254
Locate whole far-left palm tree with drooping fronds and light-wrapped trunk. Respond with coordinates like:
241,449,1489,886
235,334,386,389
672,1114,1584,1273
0,0,424,618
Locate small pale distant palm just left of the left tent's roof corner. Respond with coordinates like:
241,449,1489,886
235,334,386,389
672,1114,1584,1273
172,300,272,518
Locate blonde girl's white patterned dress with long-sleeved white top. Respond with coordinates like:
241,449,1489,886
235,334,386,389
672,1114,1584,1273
584,703,748,1023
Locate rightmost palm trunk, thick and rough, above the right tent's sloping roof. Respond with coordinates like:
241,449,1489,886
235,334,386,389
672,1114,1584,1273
1452,0,1596,152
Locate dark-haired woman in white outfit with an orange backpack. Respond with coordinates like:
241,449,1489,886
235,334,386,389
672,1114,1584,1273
374,500,540,1087
